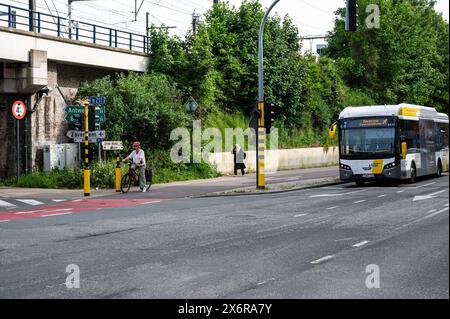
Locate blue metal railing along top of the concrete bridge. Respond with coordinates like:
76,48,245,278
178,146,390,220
0,4,149,53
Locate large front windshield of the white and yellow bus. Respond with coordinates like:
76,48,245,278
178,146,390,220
341,127,395,158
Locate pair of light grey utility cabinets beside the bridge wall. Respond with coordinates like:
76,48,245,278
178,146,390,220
44,143,80,172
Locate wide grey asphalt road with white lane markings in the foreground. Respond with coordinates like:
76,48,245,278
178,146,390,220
0,175,449,299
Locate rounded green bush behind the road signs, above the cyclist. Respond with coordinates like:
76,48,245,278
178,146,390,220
78,73,189,149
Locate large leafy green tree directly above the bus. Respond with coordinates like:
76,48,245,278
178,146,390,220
327,0,448,111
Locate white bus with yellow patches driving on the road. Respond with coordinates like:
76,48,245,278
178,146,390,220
330,104,449,185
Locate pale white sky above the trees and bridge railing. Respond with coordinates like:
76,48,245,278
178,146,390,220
4,0,449,49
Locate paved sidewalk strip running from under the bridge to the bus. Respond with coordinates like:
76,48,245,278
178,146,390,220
0,166,339,199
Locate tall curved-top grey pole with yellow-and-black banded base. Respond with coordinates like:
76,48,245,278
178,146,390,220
256,0,280,189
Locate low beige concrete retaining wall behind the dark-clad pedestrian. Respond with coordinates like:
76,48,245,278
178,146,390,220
209,147,339,174
